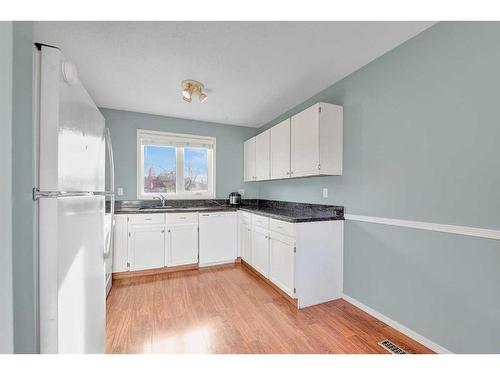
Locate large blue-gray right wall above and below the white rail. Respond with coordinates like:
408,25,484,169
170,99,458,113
259,22,500,352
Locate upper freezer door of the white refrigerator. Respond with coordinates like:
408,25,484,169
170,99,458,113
39,46,105,191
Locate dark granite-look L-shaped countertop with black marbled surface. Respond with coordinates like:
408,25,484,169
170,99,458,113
107,199,344,223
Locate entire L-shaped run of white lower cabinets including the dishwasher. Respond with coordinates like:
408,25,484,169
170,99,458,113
113,210,344,308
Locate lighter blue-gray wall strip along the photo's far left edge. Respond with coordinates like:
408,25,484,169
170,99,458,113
0,22,14,354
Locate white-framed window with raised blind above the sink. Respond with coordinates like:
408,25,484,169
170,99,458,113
137,129,215,199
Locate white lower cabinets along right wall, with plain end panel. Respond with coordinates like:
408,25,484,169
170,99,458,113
242,214,344,308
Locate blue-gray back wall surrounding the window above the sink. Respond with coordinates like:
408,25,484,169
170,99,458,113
101,108,258,200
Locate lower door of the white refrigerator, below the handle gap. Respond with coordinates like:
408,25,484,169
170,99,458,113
39,196,106,353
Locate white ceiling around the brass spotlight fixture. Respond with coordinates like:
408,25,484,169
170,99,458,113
34,22,433,127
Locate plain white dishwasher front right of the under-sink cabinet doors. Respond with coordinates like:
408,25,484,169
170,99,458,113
199,212,238,267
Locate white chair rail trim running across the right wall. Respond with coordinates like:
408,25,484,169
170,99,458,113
344,214,500,240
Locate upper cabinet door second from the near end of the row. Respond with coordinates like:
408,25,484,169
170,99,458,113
270,118,290,179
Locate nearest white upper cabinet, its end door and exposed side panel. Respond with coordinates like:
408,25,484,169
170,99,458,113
291,103,343,177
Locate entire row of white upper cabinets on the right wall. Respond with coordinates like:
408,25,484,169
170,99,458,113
244,103,343,181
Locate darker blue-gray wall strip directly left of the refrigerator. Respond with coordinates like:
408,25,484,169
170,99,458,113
12,22,39,353
